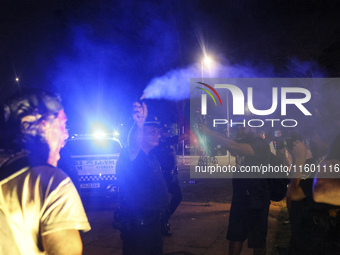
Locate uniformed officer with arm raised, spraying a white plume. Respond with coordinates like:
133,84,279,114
117,102,168,255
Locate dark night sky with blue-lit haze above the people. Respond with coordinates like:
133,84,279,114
0,0,340,136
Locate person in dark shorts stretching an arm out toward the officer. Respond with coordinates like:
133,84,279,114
199,126,271,255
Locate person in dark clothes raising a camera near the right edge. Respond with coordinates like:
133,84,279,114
287,125,339,255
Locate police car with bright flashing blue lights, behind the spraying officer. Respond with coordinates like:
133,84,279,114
65,135,122,195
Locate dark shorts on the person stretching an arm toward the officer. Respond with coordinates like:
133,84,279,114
227,188,270,248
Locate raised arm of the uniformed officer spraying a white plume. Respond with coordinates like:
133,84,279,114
128,102,148,160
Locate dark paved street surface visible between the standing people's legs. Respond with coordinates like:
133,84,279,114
83,202,280,255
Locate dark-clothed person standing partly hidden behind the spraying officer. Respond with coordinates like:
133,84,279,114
153,126,182,236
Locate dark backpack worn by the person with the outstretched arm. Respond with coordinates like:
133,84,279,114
268,153,290,202
